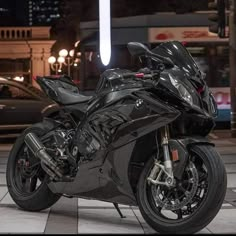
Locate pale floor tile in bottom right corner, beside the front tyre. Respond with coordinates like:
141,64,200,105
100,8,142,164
207,209,236,234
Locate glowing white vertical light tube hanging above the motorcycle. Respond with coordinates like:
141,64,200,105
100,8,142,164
99,0,111,66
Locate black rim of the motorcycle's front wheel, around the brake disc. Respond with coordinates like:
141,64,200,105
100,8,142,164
145,154,209,223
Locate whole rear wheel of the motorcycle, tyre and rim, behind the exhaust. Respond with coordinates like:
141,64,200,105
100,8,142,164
6,123,60,211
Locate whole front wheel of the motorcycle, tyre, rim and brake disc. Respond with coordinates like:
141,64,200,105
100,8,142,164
137,145,227,234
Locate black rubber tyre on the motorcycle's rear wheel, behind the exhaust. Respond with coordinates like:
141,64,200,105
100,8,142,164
6,123,60,211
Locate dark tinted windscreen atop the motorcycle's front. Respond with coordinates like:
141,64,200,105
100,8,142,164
152,41,201,77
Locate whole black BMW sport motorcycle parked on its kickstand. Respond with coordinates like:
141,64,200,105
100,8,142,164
7,41,227,233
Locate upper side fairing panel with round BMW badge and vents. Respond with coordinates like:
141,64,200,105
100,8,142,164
73,89,180,161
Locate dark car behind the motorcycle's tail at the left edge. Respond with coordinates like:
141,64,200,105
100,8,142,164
0,77,59,138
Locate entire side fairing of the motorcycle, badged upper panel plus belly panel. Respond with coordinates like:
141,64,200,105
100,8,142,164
49,90,180,205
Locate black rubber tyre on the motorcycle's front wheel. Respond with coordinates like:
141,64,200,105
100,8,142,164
137,145,227,234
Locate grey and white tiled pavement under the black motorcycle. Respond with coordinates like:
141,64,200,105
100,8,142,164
0,135,236,234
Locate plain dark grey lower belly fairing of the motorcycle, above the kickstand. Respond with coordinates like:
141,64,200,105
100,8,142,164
48,141,136,205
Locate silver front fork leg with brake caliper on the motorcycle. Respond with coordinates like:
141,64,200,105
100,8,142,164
147,126,175,187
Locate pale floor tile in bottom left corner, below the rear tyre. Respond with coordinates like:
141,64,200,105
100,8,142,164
0,207,49,233
